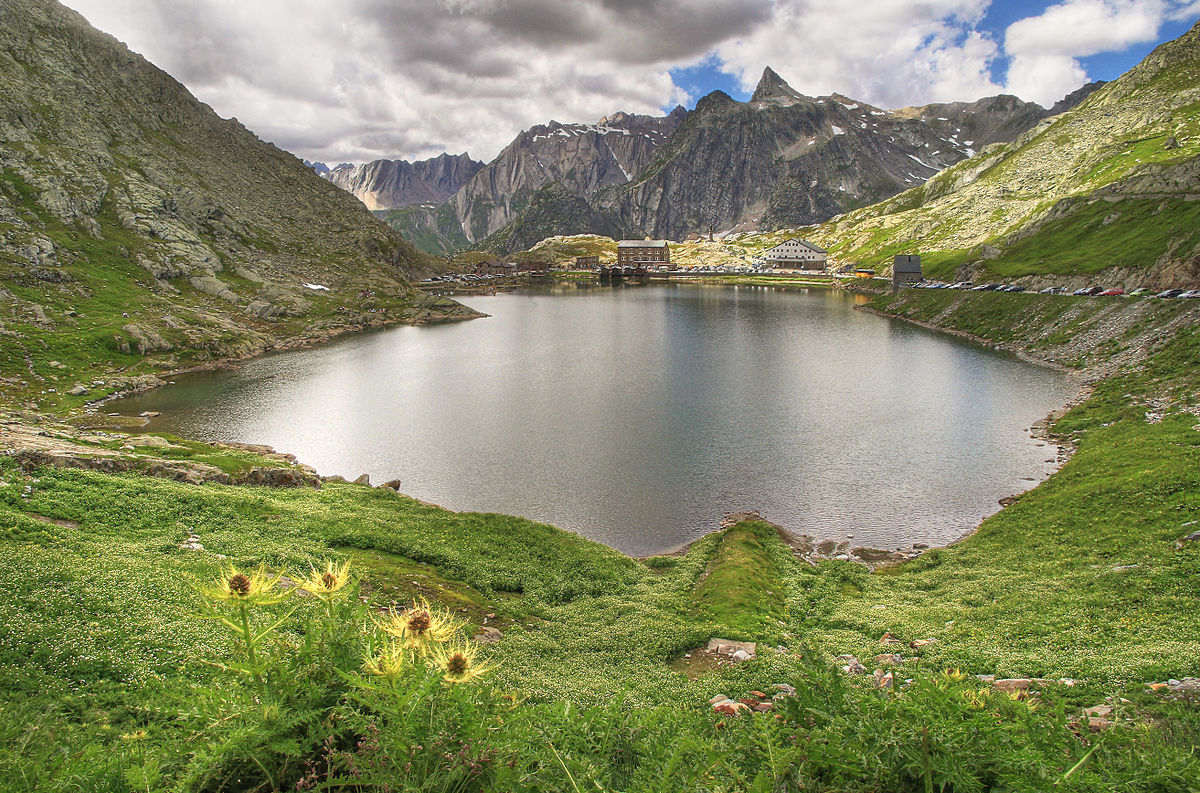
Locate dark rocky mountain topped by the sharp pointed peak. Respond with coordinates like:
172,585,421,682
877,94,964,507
602,68,1094,239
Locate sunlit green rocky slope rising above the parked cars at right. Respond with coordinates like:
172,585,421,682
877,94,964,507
804,23,1200,288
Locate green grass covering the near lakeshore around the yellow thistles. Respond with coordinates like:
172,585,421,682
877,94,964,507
7,292,1200,791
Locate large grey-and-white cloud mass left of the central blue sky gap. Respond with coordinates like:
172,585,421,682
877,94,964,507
66,0,748,162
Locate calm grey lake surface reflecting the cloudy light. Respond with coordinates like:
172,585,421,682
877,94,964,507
115,283,1075,554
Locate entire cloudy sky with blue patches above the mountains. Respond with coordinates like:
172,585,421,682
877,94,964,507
65,0,1200,163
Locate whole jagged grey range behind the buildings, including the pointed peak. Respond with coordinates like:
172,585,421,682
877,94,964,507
386,68,1082,252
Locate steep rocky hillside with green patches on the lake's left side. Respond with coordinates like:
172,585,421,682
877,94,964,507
0,0,472,405
